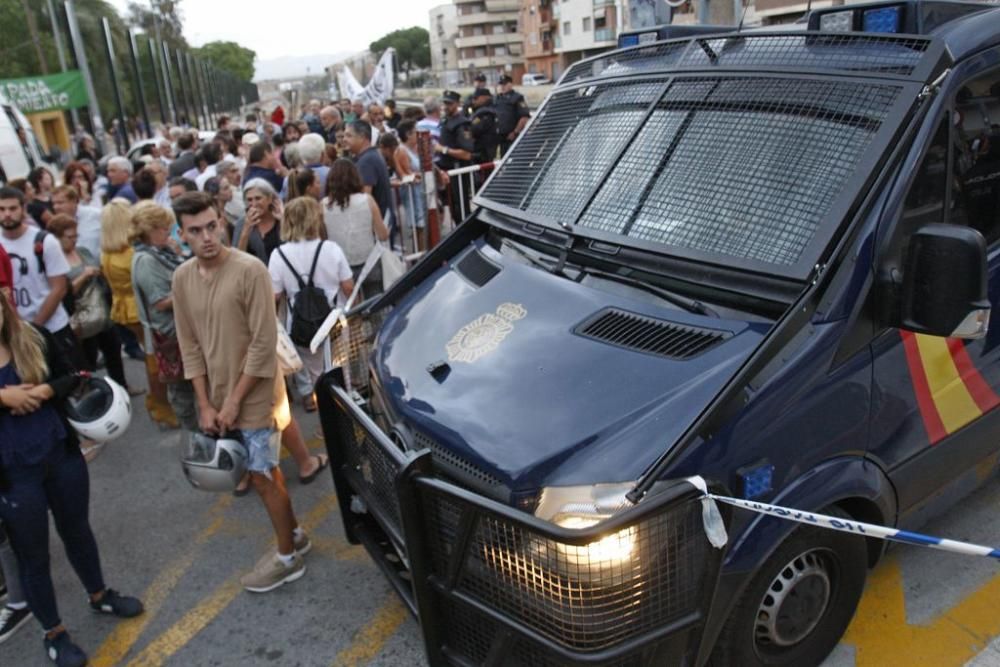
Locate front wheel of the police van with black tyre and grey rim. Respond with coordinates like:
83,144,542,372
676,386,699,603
710,507,868,667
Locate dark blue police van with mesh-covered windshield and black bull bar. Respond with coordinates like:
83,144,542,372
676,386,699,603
319,0,1000,667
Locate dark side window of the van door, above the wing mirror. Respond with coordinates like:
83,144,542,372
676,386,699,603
949,71,1000,244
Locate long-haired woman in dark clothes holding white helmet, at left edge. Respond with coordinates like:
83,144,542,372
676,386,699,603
0,292,143,667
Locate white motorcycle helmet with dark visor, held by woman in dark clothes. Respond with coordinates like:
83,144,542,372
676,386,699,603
66,375,132,442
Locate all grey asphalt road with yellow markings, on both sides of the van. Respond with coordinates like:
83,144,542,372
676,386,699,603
0,361,1000,667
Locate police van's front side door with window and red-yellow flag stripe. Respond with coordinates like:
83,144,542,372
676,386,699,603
870,55,1000,513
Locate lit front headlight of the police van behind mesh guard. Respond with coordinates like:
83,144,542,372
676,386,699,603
535,482,638,571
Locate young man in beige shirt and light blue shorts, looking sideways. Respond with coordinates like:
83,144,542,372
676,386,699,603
172,192,312,593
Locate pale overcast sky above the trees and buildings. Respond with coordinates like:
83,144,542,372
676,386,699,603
110,0,449,60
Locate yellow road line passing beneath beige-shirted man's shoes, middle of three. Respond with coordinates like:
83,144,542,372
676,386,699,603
115,493,337,667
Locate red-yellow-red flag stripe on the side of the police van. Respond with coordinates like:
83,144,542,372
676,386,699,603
900,331,1000,445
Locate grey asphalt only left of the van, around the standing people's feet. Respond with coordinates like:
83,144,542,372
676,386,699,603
0,361,423,667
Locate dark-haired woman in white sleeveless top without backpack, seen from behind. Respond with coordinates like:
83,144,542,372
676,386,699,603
322,158,389,303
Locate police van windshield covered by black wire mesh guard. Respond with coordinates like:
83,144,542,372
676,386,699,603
482,76,903,273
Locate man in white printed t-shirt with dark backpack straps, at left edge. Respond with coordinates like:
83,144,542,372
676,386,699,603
0,187,80,367
